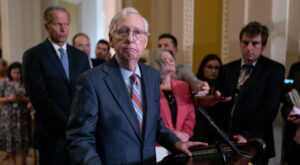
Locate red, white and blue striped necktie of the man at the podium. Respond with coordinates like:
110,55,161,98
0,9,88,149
131,73,143,130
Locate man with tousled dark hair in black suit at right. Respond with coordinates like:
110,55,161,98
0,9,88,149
210,22,285,164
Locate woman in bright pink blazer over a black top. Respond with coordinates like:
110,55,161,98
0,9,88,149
153,49,196,141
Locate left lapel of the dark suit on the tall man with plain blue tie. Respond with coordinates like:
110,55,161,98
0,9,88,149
45,39,69,83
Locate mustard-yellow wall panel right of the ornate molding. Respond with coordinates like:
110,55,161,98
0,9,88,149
193,0,222,73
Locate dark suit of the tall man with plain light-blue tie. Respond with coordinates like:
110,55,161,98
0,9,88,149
23,39,90,152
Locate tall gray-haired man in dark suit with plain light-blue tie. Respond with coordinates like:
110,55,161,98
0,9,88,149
23,7,90,165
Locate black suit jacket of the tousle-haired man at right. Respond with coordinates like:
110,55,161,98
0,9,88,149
210,56,285,157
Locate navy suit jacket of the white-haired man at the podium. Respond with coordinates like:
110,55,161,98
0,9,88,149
67,57,179,165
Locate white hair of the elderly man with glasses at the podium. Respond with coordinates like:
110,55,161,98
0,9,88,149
109,7,149,35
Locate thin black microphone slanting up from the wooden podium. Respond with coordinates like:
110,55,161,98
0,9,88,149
196,107,252,158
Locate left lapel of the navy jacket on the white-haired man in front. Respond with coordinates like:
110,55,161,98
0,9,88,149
103,57,142,140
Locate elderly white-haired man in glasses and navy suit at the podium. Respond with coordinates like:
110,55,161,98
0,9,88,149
67,8,204,165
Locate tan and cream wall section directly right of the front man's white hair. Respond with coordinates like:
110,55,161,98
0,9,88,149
123,0,193,63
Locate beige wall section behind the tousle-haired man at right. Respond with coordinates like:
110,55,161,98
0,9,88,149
222,0,300,74
